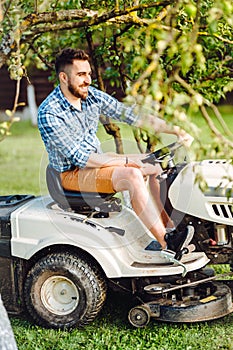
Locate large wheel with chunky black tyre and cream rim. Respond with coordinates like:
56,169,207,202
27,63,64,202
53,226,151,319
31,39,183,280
24,253,107,329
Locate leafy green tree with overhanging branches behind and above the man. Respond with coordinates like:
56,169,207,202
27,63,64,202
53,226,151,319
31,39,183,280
0,0,233,156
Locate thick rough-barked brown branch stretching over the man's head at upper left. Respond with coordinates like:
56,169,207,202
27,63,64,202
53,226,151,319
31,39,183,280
0,0,170,68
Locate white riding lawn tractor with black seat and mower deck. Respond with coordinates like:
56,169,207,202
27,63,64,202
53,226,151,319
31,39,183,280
0,143,233,329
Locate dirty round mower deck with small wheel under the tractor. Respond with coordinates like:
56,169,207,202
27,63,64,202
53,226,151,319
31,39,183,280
128,281,233,327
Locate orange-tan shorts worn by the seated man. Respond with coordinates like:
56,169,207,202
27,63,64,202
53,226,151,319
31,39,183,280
60,167,116,193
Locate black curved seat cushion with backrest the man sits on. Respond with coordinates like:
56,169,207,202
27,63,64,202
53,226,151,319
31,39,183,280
46,165,115,211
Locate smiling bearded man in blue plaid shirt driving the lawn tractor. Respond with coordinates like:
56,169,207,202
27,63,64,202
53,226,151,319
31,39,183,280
38,48,193,258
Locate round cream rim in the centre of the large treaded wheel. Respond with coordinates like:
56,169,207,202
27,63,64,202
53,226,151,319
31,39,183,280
41,276,79,315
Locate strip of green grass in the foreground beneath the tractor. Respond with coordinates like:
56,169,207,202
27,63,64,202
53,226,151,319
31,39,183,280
11,312,233,350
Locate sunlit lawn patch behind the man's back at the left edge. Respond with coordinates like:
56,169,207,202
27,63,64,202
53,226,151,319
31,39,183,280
0,121,45,195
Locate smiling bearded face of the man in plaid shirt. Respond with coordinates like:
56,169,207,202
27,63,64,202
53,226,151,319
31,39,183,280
66,60,91,100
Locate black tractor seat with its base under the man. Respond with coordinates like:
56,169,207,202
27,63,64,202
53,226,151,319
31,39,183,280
46,165,121,214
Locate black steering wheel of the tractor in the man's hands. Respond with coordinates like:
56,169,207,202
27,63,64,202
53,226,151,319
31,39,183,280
142,142,182,165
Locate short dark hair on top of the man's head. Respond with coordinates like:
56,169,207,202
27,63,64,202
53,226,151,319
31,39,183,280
55,48,89,75
